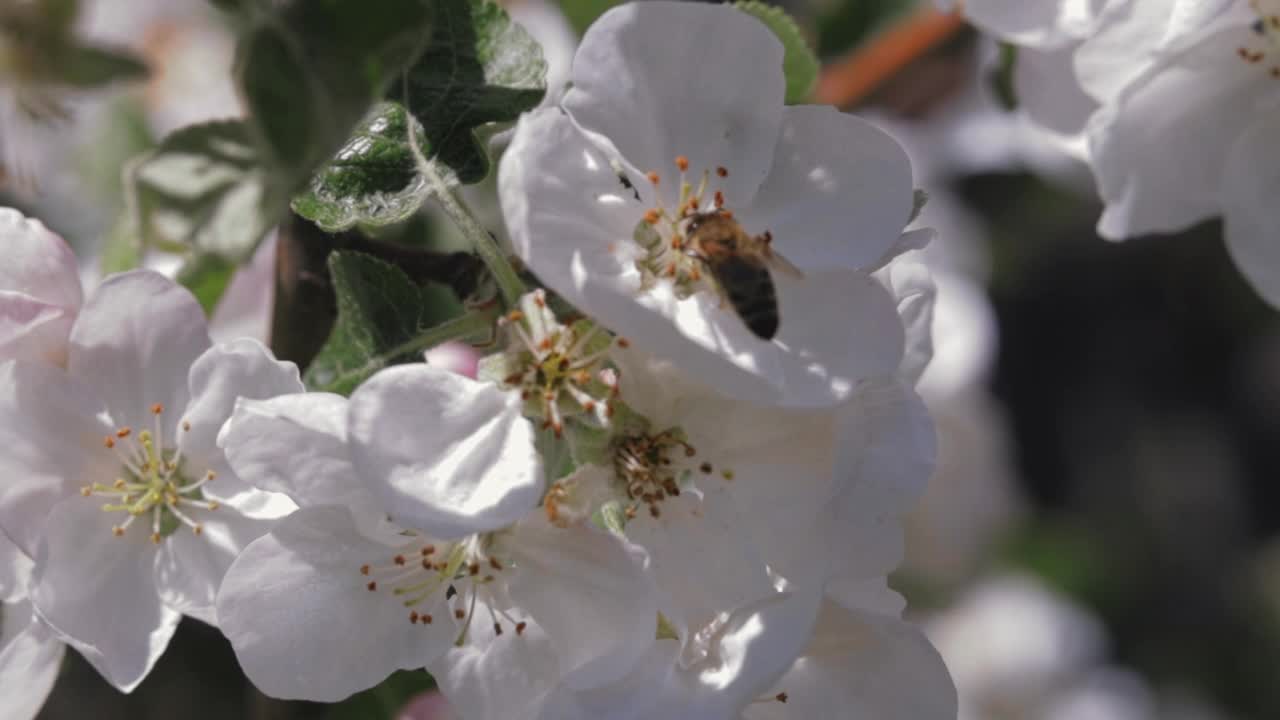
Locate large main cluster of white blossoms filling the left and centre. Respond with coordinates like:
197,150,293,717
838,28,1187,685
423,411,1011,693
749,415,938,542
0,1,956,720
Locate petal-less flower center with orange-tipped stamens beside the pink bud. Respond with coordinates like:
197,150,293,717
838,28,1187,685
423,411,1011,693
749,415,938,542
485,284,626,437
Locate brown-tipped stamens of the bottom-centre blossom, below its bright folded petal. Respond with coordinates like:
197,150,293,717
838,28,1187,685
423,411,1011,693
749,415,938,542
360,530,526,646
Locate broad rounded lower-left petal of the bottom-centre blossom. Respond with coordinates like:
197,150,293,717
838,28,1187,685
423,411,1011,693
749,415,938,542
218,507,453,702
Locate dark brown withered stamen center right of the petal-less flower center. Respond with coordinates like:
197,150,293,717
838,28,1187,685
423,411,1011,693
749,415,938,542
613,428,733,518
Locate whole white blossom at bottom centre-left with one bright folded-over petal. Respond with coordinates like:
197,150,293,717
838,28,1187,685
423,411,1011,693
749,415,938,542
218,365,657,702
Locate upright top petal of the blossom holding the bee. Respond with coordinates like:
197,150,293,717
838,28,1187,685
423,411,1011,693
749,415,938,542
563,0,786,206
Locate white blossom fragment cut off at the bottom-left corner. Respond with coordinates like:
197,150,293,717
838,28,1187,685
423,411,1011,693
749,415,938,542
0,533,65,720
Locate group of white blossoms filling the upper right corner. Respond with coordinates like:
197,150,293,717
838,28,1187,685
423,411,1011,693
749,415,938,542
941,0,1280,305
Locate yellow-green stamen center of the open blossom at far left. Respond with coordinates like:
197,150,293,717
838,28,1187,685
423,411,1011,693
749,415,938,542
81,404,218,544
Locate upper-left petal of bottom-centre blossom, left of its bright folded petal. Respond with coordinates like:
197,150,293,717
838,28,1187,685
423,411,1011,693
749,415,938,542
215,392,369,507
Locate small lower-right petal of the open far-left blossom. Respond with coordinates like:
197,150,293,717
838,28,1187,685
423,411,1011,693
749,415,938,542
155,509,271,625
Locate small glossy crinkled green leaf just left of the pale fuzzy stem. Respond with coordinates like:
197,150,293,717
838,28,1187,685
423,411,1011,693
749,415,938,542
293,102,430,232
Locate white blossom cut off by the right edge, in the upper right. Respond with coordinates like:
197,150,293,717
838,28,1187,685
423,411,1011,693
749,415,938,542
1089,0,1280,305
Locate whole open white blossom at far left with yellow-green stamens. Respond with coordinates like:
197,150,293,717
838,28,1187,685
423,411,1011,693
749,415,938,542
0,270,302,692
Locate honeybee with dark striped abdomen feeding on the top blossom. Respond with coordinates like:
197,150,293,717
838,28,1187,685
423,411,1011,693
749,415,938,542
685,210,804,340
